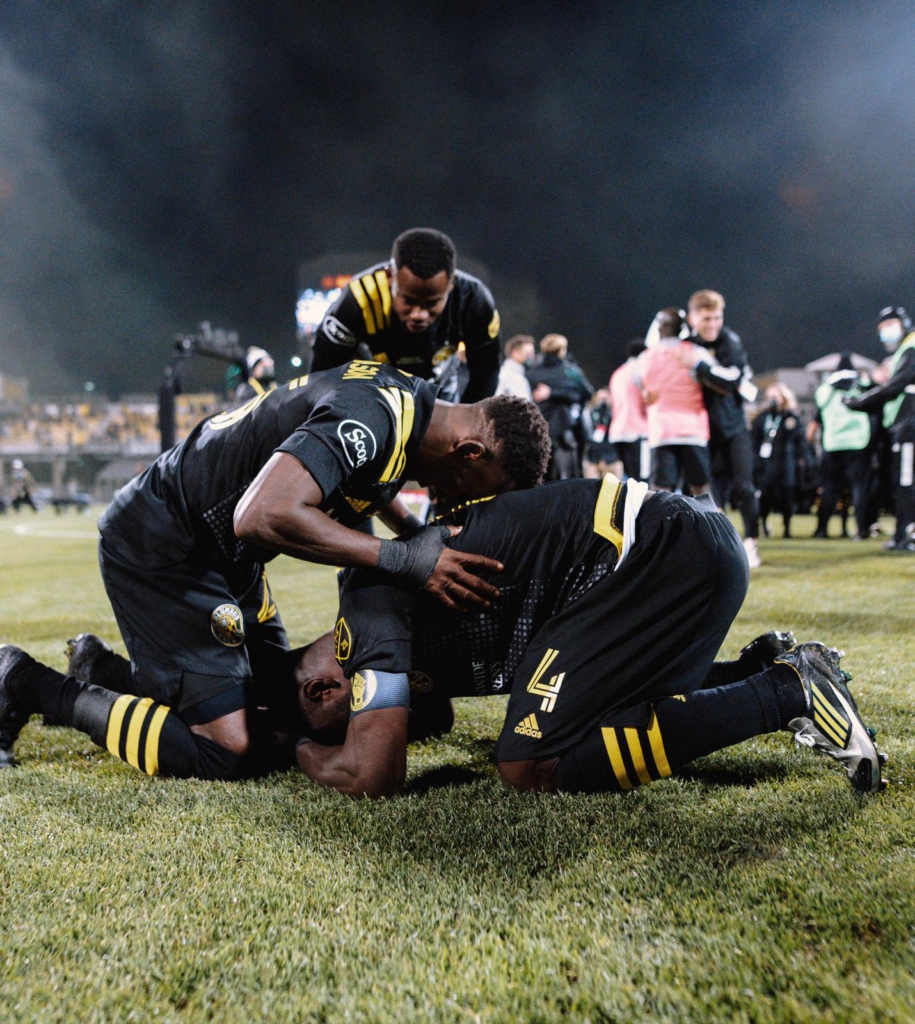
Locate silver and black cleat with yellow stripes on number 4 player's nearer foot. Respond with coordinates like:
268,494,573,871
775,641,886,793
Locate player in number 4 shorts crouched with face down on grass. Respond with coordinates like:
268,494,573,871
0,477,883,797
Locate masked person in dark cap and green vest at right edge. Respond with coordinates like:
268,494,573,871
844,306,915,554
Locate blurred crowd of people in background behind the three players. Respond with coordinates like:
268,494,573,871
0,290,915,566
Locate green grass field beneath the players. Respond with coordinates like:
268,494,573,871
0,511,915,1024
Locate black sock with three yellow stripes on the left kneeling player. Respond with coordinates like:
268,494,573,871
7,662,245,779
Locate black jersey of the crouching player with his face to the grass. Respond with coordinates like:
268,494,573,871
336,477,625,696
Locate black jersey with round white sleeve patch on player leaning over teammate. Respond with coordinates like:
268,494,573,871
99,361,436,567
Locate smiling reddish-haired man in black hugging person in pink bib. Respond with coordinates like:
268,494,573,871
682,289,759,568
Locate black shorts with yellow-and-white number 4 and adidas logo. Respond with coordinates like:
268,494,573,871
495,494,749,761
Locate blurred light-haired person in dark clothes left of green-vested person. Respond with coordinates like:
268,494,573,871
750,384,807,538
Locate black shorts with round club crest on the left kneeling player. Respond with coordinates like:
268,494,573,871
98,541,289,725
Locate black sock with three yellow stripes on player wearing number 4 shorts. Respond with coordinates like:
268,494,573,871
557,665,804,793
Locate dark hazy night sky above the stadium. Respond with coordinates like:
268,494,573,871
0,0,915,395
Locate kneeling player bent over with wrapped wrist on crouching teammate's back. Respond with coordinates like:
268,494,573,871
0,362,549,779
